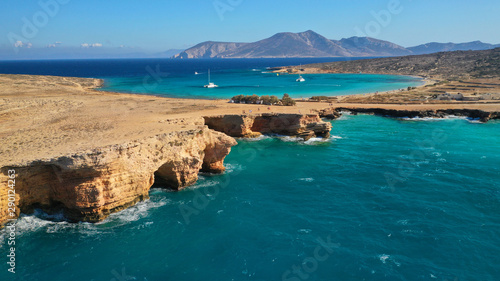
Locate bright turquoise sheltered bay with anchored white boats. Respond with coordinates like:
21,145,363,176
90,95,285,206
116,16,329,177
103,68,422,98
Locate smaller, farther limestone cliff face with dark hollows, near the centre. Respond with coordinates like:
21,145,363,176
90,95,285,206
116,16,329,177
204,113,332,140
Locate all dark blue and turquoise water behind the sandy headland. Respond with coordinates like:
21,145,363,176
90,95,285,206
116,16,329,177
0,58,422,99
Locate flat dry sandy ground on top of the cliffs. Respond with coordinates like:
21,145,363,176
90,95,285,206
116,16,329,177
0,75,500,166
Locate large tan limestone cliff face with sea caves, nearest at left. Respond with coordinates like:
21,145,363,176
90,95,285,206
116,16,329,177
0,127,236,224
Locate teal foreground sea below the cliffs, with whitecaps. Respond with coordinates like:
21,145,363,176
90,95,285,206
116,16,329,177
0,115,500,281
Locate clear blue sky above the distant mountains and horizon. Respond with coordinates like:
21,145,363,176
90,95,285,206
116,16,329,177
0,0,500,55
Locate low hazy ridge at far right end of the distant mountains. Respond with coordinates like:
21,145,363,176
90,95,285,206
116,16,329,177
408,41,500,55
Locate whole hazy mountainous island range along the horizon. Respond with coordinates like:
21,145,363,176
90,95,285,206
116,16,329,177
172,30,500,59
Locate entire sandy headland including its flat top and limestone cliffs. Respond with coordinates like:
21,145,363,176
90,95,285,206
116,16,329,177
0,75,499,226
